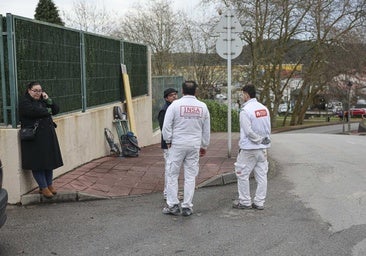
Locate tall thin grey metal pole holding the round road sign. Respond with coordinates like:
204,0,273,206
227,10,231,158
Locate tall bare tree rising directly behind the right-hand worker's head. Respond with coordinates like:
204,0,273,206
216,0,309,127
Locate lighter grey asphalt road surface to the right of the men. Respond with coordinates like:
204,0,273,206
270,131,366,255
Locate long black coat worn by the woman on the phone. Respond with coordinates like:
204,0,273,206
19,93,63,170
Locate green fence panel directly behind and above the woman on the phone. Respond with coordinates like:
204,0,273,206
14,19,81,112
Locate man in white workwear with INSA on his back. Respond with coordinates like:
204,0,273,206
162,81,210,216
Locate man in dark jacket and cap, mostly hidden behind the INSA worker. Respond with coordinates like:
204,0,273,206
158,88,178,199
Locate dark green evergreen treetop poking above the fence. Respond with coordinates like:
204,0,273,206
34,0,64,26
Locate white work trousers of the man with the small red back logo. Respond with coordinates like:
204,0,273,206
235,149,268,206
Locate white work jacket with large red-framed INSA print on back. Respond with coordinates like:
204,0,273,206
162,95,211,149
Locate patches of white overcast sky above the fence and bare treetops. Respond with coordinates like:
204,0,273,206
0,0,200,19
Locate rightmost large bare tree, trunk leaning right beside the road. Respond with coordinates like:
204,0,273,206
290,0,366,125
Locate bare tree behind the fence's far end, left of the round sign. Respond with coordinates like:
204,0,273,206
114,0,185,75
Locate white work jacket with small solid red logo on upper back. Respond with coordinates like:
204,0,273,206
239,98,271,149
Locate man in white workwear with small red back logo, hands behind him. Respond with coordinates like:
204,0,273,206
233,85,271,210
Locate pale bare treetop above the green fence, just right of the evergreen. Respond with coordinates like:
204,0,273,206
63,0,117,35
